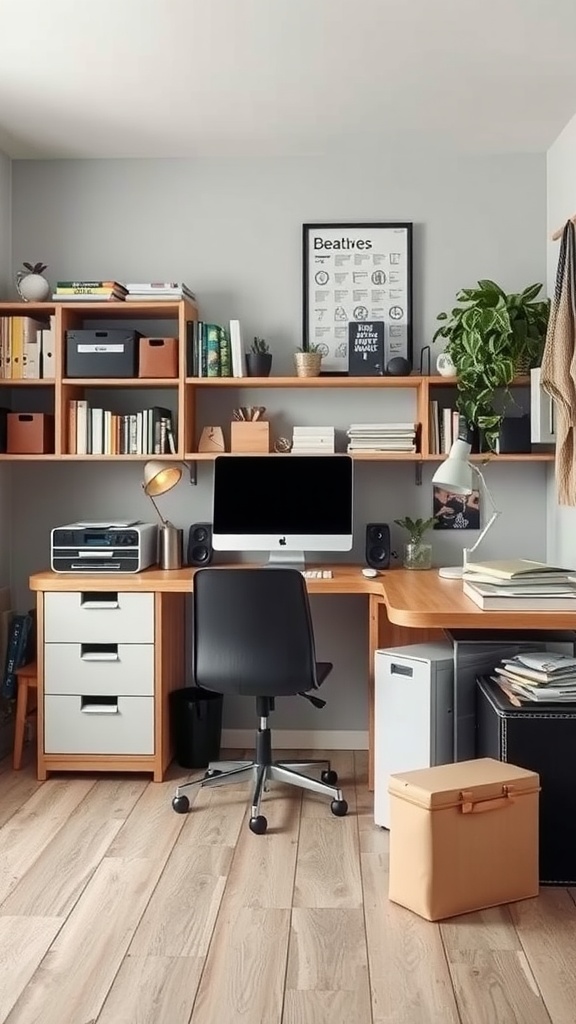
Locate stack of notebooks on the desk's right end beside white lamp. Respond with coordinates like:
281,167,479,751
462,558,576,611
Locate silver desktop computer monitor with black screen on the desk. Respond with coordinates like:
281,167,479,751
212,455,354,569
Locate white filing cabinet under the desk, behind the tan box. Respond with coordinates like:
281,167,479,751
374,641,454,828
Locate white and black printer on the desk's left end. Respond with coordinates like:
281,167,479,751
50,519,158,573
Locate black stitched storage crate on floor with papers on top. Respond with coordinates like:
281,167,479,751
477,676,576,886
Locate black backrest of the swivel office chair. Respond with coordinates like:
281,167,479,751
193,568,318,696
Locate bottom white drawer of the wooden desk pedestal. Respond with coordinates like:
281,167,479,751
44,693,154,754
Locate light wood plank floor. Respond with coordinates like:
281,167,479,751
0,752,576,1024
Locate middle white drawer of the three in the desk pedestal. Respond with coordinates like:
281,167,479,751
44,643,154,696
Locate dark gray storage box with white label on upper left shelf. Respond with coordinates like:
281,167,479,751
66,328,141,377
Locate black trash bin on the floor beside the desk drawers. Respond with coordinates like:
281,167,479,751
170,686,223,768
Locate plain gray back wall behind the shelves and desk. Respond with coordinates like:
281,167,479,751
8,154,545,729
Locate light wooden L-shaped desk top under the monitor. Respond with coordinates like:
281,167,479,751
30,563,576,630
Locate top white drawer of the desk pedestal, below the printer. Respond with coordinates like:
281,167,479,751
44,591,154,643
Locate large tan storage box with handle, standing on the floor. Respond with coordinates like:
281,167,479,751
388,758,540,921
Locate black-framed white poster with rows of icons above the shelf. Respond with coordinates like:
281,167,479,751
302,223,412,374
